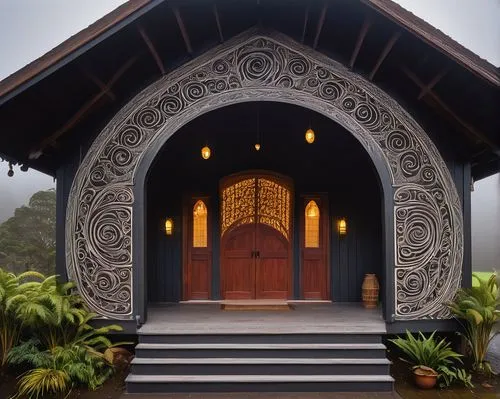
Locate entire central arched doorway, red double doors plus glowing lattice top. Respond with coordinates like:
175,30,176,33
220,172,293,299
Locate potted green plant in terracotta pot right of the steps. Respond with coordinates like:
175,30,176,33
389,331,472,389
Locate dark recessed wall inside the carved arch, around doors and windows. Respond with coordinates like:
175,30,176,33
146,102,383,302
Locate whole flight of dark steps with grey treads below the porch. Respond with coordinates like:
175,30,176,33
126,332,394,393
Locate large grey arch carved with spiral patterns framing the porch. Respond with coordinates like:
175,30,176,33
66,32,463,319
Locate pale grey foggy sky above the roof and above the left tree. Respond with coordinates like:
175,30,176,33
0,0,500,222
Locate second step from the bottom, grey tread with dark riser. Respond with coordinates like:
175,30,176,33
131,358,390,375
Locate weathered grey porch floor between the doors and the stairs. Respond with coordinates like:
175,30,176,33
138,302,387,335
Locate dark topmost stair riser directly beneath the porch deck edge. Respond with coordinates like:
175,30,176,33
139,333,382,344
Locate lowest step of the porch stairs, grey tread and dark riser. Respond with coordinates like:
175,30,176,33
126,374,394,393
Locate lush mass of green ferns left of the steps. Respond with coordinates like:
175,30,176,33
0,269,126,398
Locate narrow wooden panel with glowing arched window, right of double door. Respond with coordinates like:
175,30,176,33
300,195,330,300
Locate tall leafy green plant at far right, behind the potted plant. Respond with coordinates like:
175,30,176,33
450,273,500,374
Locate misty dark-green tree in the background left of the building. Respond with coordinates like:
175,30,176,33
0,189,56,275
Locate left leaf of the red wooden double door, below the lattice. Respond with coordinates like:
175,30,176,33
221,224,255,299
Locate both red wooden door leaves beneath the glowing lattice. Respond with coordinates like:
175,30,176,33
221,223,290,299
